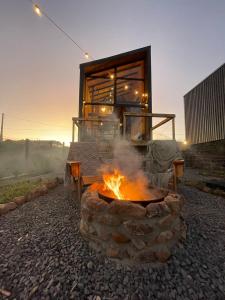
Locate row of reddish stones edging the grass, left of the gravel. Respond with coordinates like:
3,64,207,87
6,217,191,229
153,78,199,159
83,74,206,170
0,177,63,216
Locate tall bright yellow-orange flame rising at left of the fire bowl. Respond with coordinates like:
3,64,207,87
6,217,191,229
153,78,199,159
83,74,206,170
103,169,124,200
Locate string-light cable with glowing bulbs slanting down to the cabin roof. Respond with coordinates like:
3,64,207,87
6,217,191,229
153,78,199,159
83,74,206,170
28,0,93,59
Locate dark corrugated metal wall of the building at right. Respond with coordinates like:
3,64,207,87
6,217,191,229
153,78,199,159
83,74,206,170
184,64,225,144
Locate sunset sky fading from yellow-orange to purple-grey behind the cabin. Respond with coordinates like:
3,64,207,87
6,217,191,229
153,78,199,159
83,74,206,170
0,0,225,143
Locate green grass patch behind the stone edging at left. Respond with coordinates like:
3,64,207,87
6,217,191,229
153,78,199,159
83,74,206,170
0,179,44,203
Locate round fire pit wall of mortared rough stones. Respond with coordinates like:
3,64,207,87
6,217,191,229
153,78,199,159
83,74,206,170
80,188,186,262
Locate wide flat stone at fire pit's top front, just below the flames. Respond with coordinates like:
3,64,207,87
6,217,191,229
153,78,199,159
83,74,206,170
108,200,146,218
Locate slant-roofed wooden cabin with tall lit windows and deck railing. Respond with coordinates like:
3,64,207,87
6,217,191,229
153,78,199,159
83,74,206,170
73,46,175,143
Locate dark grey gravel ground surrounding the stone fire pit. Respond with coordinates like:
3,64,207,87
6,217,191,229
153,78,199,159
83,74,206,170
0,186,225,300
